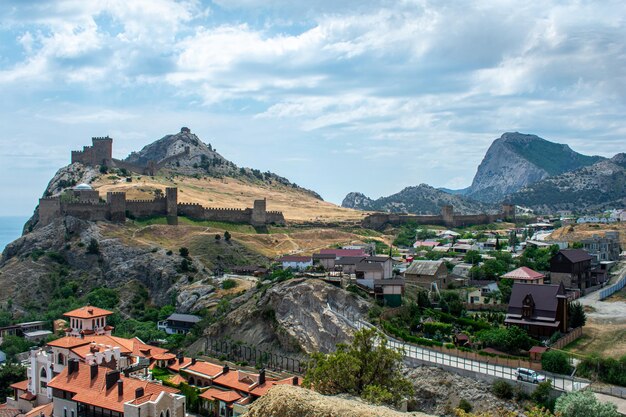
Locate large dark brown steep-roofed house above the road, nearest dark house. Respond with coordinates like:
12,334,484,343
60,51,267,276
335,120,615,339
504,282,569,339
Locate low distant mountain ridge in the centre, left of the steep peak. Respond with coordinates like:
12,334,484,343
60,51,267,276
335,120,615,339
341,184,494,214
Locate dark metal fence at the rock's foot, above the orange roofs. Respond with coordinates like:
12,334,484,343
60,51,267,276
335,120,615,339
204,337,306,375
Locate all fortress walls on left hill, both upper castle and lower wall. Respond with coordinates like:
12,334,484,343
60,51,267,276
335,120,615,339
39,132,285,226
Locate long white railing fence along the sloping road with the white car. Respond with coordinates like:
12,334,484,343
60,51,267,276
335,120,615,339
328,304,589,391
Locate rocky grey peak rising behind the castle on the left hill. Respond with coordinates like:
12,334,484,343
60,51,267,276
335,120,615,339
124,128,322,200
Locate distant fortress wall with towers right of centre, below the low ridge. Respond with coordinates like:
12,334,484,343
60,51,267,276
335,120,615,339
361,204,515,229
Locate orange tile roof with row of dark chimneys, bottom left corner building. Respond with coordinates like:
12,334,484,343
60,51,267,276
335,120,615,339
48,362,180,412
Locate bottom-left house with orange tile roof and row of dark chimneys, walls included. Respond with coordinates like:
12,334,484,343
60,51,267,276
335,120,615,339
48,360,185,417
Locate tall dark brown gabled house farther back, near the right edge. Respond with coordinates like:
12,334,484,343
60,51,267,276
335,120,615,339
550,249,596,291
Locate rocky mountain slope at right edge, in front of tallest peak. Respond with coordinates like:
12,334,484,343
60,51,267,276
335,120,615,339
507,153,626,213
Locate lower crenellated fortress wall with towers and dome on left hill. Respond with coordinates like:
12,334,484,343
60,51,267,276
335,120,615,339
39,184,285,227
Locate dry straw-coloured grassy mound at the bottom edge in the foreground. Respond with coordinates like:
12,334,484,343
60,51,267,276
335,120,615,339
244,385,432,417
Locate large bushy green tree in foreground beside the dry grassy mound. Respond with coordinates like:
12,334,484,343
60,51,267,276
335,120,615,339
304,329,413,404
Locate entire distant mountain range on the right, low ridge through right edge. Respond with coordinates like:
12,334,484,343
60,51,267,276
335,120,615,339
342,132,626,214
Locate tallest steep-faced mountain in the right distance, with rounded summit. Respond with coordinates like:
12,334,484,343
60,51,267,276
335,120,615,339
465,132,604,203
